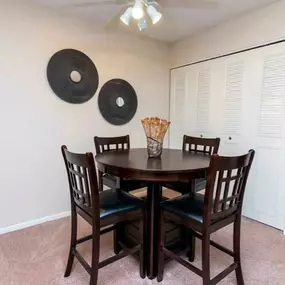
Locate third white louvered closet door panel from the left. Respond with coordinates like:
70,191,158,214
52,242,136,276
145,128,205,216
213,49,254,155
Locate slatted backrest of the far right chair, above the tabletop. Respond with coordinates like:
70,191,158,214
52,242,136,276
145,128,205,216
182,135,220,155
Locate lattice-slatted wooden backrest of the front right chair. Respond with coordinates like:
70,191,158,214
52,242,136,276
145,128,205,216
204,150,255,222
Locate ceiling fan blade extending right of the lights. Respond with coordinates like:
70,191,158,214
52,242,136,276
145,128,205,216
157,0,216,9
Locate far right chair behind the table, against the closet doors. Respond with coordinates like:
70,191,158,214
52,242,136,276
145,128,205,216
165,135,220,194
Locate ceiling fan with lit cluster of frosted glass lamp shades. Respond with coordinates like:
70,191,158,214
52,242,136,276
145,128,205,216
60,0,218,31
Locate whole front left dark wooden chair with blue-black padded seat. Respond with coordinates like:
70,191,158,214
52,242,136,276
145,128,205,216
61,146,145,285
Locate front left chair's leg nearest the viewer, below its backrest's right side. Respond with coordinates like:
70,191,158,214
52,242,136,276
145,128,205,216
90,225,100,285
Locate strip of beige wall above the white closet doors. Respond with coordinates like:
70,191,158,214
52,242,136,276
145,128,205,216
170,0,285,67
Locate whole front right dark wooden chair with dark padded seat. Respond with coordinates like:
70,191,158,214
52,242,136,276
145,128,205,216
157,150,255,285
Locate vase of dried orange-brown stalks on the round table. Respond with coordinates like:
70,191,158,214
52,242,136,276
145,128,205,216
142,117,170,157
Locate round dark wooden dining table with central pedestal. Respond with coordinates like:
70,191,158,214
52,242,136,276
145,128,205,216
95,148,210,279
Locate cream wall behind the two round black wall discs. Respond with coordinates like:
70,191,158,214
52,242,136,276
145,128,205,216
0,0,169,226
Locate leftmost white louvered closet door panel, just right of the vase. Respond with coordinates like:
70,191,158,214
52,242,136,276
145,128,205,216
169,68,188,149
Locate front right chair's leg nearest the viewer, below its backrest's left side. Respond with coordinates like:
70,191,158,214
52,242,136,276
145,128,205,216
202,231,211,285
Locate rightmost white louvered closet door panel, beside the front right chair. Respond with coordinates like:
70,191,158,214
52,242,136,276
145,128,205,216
243,44,285,230
